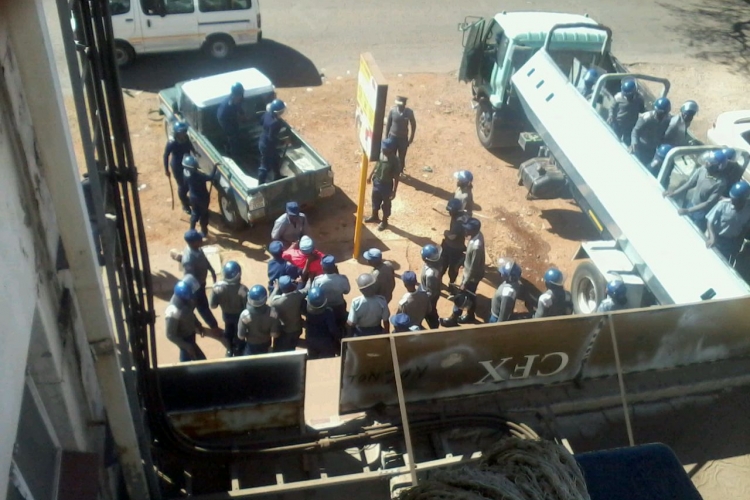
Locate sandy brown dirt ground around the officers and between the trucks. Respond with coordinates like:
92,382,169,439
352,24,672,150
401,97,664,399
83,60,743,363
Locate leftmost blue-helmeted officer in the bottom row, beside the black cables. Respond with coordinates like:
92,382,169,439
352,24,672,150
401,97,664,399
164,280,206,362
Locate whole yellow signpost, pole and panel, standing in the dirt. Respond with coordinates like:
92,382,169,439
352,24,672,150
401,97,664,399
354,52,388,259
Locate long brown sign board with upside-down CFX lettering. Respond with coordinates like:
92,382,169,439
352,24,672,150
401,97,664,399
339,298,750,414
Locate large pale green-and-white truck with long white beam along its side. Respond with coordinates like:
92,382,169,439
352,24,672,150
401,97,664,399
459,12,750,313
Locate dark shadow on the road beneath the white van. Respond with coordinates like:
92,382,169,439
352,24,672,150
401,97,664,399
120,40,322,92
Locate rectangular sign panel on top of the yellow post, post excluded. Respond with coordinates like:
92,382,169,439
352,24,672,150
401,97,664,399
355,52,388,161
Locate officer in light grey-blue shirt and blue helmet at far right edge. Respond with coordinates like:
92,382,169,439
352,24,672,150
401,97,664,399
706,180,750,263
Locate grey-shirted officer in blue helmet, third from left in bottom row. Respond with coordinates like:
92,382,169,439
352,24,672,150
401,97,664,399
237,285,280,356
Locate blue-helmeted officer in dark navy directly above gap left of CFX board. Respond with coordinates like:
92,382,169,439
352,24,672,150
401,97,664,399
305,286,341,359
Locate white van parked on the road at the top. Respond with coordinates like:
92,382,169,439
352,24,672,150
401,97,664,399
109,0,261,67
